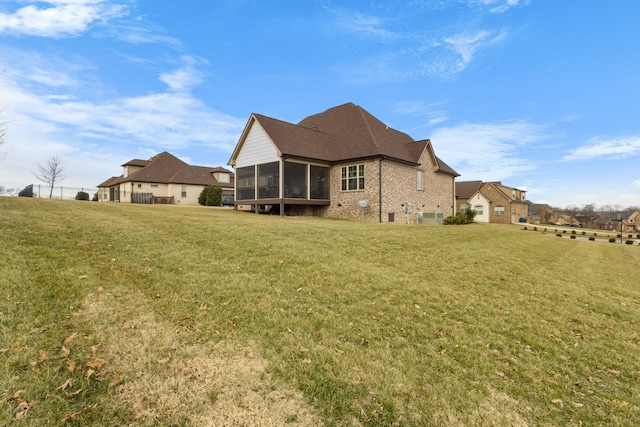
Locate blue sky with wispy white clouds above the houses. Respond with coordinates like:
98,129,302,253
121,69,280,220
0,0,640,207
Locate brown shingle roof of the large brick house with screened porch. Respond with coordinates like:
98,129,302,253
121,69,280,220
242,103,458,176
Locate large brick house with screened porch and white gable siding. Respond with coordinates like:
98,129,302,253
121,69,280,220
228,103,458,222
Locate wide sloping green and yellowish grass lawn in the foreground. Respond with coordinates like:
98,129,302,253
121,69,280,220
0,197,640,426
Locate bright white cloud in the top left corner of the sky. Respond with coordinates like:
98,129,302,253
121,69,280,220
0,0,127,38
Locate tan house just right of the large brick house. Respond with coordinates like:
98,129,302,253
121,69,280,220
456,181,529,224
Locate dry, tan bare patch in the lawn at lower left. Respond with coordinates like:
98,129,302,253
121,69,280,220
80,292,321,426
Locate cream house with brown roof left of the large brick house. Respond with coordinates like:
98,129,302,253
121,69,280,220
98,151,234,205
